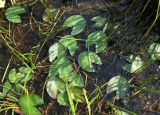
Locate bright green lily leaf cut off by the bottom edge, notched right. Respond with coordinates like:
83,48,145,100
19,94,44,115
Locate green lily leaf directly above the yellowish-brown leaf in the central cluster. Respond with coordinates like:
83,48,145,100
70,75,84,87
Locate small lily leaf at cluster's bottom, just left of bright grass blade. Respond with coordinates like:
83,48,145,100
57,93,69,106
